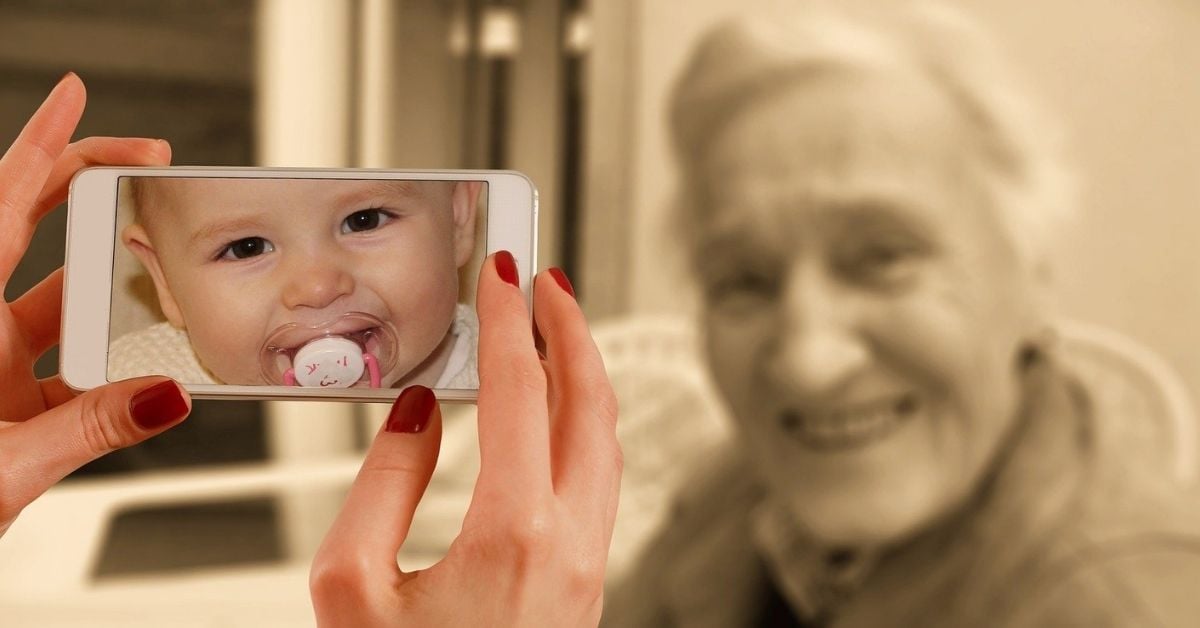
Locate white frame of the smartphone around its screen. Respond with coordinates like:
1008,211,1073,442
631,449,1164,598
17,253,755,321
59,166,538,402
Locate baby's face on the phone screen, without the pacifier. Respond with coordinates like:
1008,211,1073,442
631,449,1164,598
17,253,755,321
125,179,479,385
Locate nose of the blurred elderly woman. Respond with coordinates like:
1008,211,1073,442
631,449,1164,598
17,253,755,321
767,273,871,397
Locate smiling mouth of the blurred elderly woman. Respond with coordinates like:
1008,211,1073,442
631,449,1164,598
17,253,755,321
779,395,920,450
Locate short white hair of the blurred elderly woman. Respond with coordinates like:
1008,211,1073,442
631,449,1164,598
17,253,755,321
670,2,1076,272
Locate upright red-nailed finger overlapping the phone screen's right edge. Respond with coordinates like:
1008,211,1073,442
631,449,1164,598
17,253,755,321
475,251,552,501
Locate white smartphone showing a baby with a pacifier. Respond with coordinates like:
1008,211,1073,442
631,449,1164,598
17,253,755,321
60,167,538,401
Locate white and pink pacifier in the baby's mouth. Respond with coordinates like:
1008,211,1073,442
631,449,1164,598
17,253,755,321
259,312,396,388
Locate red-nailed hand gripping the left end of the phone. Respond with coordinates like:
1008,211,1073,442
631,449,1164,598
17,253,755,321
0,74,191,536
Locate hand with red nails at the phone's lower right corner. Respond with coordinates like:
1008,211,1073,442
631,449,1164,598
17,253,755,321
311,252,622,627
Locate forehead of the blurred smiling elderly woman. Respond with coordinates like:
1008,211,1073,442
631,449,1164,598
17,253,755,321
690,71,982,241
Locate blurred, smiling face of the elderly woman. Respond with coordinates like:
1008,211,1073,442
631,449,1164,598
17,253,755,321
696,74,1037,544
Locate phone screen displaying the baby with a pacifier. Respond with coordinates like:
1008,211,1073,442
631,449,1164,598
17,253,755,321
107,177,487,389
